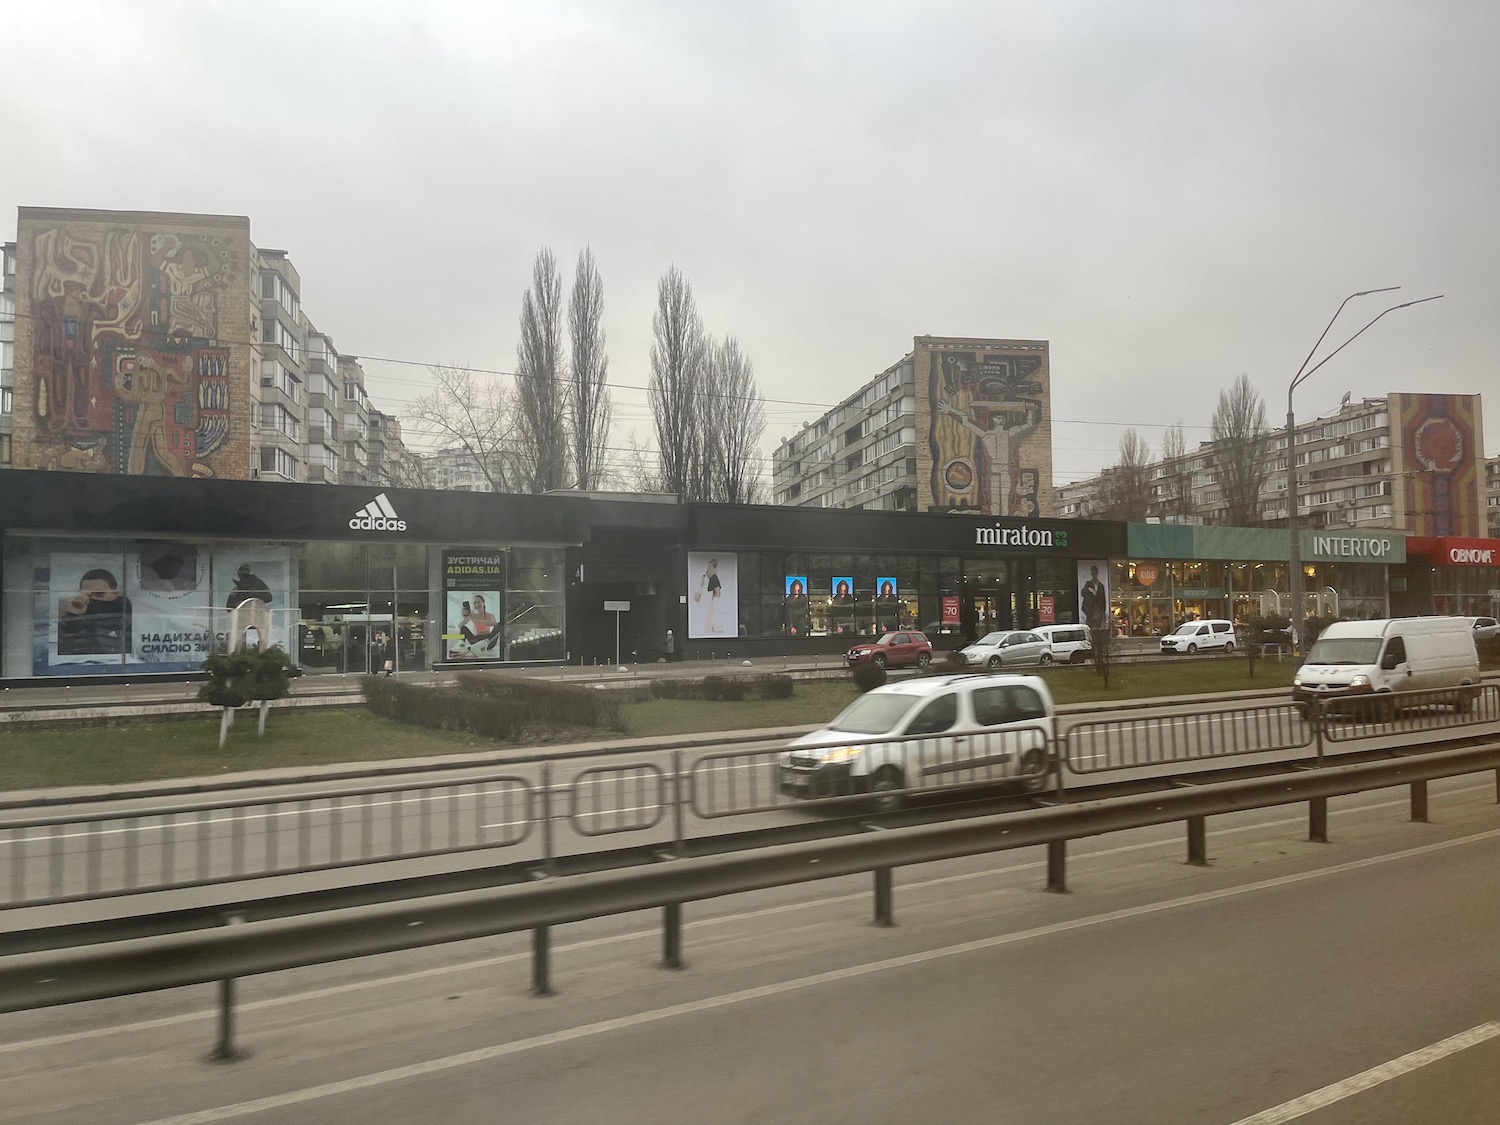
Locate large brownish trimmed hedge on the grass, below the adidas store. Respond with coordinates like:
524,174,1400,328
362,672,623,743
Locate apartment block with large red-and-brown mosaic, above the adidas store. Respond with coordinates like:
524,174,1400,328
0,207,402,483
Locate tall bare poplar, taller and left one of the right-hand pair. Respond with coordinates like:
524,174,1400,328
648,266,708,500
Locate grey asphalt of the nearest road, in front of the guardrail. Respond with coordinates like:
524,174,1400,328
0,774,1500,1125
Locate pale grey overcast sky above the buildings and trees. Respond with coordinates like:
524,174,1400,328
0,0,1500,483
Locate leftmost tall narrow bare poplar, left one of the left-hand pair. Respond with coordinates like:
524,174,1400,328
516,248,569,492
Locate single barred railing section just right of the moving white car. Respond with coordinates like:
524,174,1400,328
1062,704,1316,774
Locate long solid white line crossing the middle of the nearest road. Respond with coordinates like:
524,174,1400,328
132,828,1500,1125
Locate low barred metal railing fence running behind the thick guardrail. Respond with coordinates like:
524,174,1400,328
0,693,1500,909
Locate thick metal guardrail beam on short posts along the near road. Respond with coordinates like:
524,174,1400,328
0,743,1500,1059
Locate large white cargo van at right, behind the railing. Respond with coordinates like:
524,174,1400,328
1292,617,1479,707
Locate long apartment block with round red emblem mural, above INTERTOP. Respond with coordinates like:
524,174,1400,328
1053,393,1488,536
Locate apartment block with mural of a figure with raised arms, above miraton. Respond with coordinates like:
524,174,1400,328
771,336,1052,518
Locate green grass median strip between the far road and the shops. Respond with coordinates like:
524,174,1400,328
0,660,1295,791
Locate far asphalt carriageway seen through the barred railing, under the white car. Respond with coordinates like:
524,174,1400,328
0,704,1500,926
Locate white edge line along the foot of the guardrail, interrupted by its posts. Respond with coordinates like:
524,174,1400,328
0,785,1490,1055
